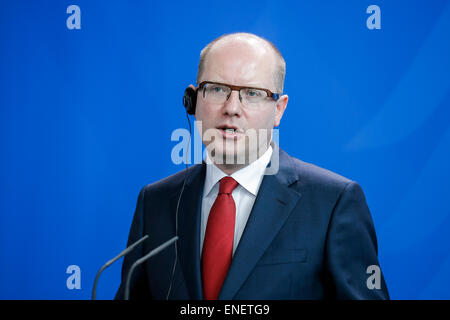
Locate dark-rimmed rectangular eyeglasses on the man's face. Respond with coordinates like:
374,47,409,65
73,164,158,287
198,81,280,107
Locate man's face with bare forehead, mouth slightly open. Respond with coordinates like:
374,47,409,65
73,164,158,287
195,40,287,165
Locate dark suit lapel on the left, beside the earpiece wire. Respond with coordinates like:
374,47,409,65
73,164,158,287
172,164,205,300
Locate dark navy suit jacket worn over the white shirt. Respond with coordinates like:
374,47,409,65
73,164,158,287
116,149,389,299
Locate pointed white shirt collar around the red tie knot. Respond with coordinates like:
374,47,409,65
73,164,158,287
203,145,273,197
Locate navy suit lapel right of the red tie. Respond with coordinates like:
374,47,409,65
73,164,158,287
219,150,301,300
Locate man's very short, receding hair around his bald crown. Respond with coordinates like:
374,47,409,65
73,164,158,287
197,32,286,93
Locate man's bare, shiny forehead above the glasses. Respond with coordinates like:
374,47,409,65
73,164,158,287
200,39,275,89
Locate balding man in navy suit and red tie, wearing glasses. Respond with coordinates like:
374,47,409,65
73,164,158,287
116,33,389,299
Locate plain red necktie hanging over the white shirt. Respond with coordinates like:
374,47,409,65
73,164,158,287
202,177,238,300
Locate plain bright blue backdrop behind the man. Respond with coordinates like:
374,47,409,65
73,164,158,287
0,0,450,299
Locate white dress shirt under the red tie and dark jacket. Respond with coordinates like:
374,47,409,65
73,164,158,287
200,145,273,255
